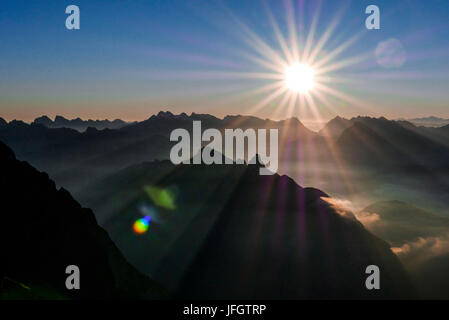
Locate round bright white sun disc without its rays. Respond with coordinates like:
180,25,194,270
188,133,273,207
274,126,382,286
284,62,315,93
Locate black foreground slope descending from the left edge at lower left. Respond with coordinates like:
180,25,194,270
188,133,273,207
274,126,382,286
0,142,166,299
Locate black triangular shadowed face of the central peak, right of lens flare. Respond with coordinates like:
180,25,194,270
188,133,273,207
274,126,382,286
174,166,411,299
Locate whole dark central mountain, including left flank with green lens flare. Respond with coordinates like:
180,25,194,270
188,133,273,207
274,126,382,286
53,149,413,299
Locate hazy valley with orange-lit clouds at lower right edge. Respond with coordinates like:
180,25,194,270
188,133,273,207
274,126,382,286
357,201,449,299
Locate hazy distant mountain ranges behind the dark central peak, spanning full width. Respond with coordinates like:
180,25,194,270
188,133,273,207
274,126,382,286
0,112,449,209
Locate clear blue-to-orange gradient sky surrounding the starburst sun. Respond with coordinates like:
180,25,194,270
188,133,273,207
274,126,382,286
0,0,449,121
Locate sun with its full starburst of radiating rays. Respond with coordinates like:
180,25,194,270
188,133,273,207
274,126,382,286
184,0,372,118
